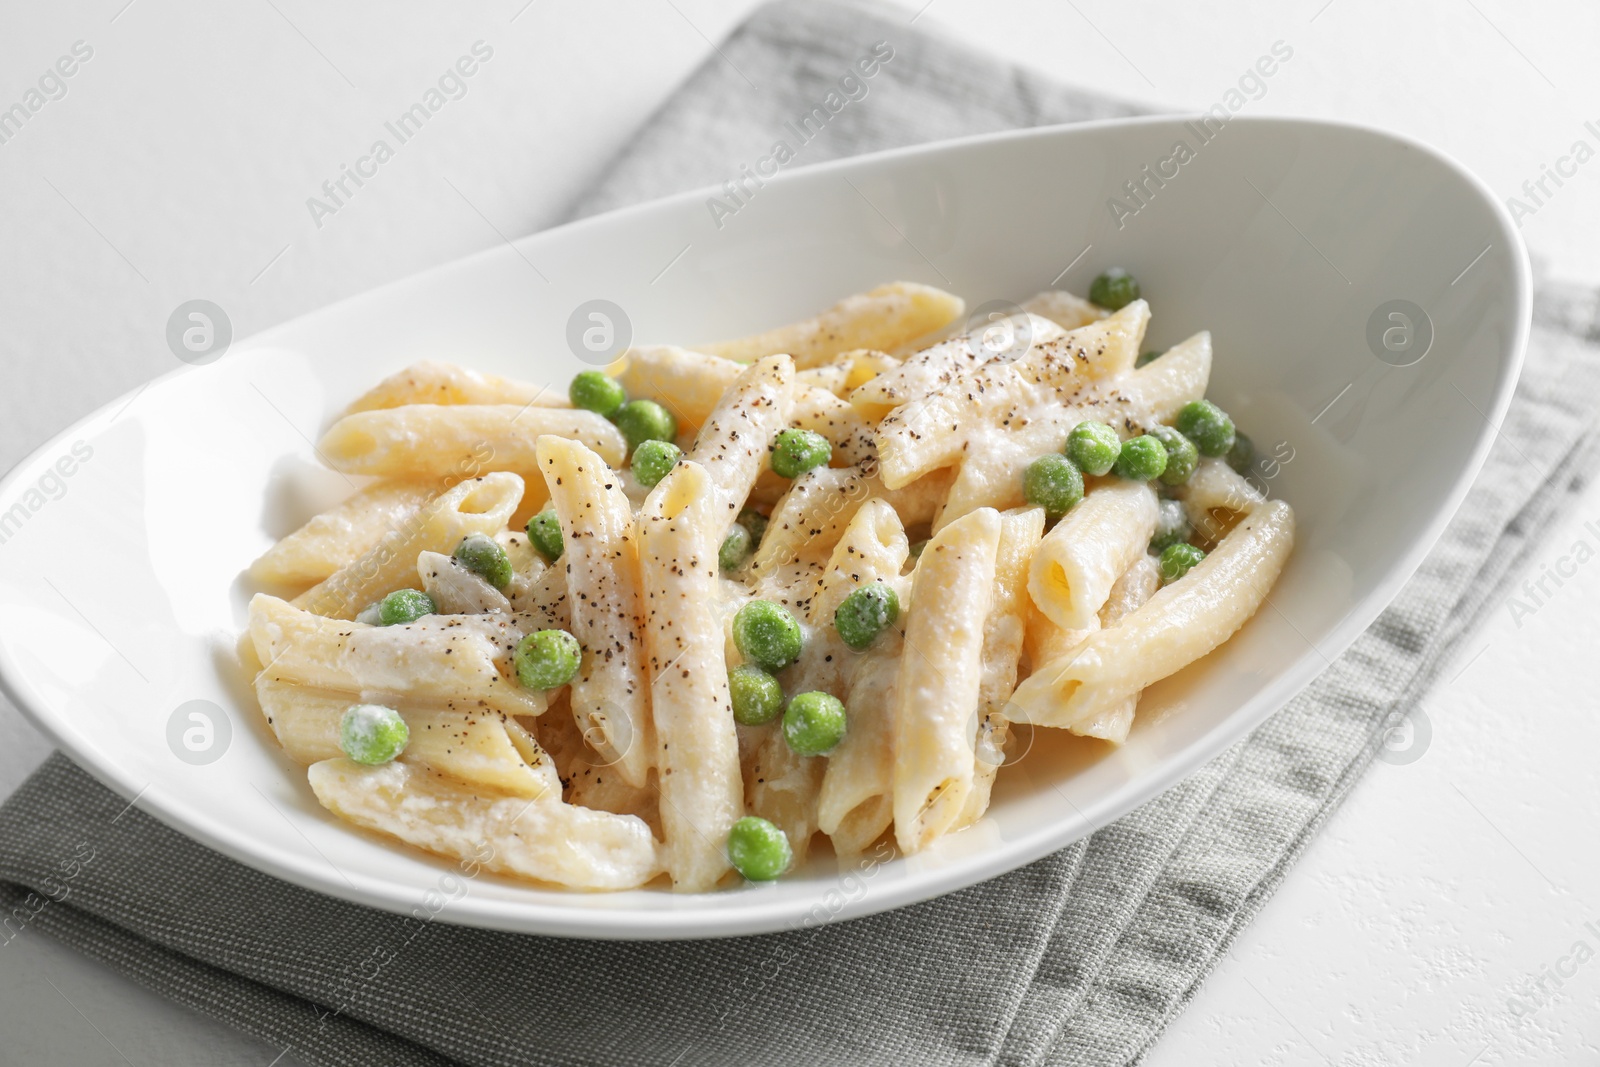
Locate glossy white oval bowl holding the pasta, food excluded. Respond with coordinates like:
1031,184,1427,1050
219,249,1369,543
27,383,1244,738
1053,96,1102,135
0,118,1530,937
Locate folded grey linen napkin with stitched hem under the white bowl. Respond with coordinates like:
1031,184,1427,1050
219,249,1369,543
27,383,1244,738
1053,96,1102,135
0,3,1600,1067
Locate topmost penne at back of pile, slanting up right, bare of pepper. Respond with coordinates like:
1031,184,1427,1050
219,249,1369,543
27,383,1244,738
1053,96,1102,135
701,282,965,370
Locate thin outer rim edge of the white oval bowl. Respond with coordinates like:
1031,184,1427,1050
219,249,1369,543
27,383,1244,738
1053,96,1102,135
0,112,1533,941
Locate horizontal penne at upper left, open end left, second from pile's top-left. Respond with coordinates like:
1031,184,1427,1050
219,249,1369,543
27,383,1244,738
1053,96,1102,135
317,403,627,478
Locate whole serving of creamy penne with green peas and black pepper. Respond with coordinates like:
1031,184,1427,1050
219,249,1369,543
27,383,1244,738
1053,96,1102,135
242,269,1294,891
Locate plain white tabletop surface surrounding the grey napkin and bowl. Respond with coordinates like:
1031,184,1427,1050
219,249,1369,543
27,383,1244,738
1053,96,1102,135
0,0,1600,1067
